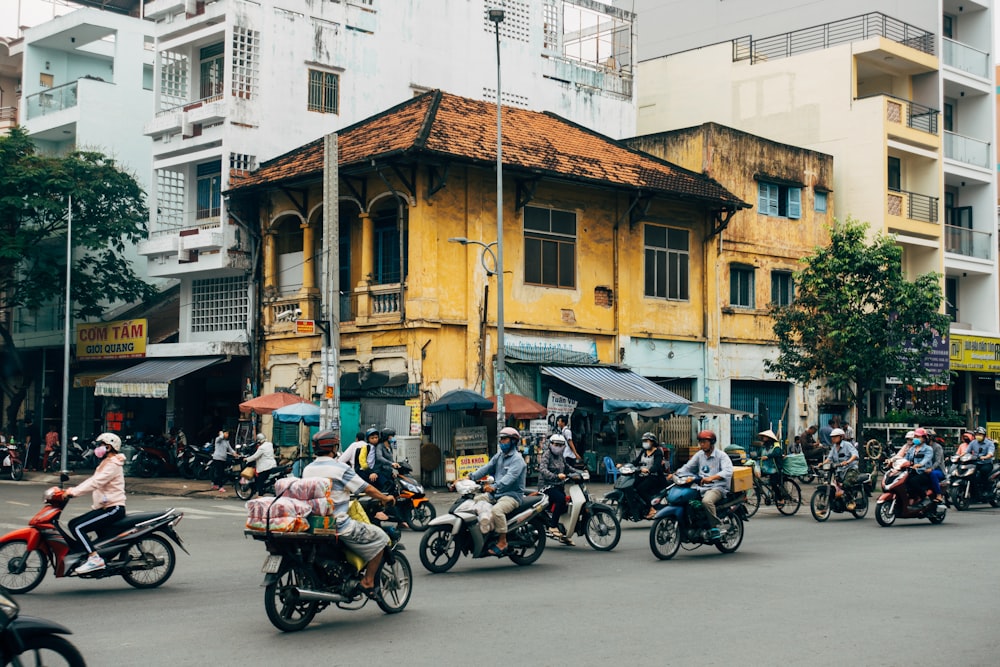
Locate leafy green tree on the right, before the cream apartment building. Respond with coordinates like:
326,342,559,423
765,218,949,436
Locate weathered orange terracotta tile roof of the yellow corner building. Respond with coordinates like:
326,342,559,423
232,91,749,208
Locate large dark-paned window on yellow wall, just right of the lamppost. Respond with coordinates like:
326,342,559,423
524,206,576,288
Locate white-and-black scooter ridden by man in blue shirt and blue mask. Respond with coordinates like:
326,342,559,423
420,478,548,573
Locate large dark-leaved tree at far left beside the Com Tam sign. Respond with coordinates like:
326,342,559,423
0,127,154,424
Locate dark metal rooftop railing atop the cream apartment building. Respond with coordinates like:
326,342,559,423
748,12,934,63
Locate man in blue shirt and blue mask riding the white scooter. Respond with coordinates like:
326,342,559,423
469,426,528,557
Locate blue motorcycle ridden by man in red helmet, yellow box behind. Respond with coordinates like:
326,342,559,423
649,477,749,560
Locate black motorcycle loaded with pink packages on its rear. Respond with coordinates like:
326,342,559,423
245,504,413,632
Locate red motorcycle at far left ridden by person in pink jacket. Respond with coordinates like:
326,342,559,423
0,480,188,593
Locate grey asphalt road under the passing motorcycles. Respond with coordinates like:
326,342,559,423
0,482,1000,667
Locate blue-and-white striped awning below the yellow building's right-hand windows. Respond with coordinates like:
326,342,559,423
542,366,691,415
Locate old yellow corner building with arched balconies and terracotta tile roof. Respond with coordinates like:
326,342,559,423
230,91,748,460
